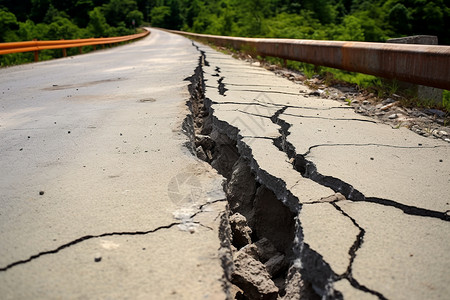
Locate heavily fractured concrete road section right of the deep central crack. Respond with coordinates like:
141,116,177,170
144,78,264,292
200,41,450,299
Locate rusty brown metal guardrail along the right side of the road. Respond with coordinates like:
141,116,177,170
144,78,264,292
171,31,450,90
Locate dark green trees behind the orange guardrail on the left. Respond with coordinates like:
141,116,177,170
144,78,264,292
0,0,144,65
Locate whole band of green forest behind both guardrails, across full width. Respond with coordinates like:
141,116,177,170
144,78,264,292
0,0,450,65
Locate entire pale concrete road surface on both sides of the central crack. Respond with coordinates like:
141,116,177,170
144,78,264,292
0,29,450,299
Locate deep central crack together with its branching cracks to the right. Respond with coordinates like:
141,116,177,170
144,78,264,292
185,40,450,299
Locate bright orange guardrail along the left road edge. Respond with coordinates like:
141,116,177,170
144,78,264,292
0,29,150,61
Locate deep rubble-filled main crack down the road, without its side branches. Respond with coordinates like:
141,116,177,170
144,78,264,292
184,42,326,299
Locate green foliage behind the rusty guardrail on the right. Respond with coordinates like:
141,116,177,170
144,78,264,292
146,0,450,44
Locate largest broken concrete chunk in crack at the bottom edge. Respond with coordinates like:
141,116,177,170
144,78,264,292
231,252,278,300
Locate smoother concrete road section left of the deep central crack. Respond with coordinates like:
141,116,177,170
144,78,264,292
0,30,226,299
